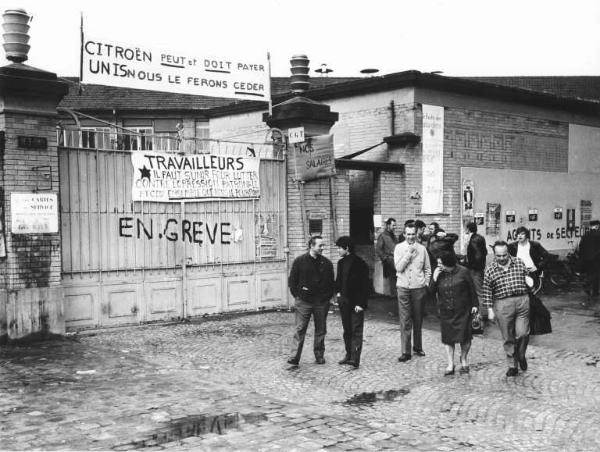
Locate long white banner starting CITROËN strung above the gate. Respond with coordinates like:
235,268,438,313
82,36,271,102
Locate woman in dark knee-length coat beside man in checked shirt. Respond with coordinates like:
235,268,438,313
433,251,479,375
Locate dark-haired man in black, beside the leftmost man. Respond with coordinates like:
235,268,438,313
335,236,370,368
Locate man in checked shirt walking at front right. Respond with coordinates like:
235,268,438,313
483,241,529,377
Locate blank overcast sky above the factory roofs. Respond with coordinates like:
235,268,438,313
0,0,600,76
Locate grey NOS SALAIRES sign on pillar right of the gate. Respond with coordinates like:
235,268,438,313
294,135,335,181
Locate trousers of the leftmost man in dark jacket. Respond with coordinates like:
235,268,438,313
292,298,329,360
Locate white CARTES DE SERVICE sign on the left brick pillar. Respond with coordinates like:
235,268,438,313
10,193,58,234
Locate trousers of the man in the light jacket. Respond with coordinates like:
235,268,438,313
398,287,427,355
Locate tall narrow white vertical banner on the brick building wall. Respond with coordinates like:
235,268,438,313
421,105,444,213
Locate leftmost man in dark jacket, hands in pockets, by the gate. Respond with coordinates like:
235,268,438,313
287,235,335,365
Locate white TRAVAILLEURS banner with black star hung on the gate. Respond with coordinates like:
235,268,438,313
131,151,260,202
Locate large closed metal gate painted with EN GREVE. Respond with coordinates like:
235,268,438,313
59,132,287,330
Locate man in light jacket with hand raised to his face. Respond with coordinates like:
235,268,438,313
394,223,431,362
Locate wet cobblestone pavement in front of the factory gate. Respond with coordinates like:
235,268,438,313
0,286,600,451
